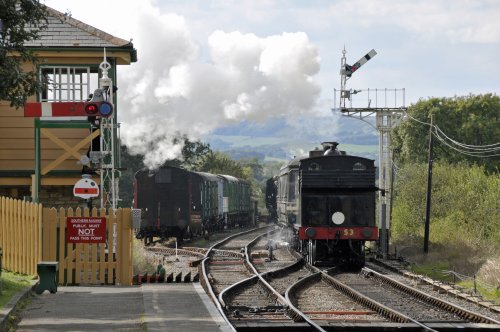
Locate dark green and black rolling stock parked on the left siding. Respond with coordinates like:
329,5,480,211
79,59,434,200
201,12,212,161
134,166,256,243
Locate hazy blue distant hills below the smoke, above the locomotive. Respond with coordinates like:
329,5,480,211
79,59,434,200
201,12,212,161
203,118,378,161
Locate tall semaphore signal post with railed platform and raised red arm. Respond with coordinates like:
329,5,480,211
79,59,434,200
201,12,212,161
333,48,407,258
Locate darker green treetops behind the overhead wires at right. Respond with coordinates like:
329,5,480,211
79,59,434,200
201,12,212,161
392,94,500,172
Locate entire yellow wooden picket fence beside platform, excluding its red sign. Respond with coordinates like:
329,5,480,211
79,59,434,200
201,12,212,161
0,197,133,285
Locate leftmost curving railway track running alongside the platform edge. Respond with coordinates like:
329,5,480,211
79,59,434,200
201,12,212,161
201,224,323,331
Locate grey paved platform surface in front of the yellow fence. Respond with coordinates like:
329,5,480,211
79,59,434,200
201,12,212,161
17,283,230,332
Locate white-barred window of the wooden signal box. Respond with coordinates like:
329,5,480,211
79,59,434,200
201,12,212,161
39,66,99,102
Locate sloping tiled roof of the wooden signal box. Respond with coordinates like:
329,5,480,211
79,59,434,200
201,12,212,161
24,7,137,62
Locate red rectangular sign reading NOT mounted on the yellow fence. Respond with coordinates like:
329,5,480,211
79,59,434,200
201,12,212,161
66,217,106,243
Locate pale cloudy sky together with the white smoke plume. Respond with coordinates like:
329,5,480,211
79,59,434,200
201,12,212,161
42,0,500,167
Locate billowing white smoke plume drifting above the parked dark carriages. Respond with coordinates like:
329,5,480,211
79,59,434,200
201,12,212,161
118,8,320,168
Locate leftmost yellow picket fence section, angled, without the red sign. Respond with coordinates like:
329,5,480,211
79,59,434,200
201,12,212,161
0,197,42,275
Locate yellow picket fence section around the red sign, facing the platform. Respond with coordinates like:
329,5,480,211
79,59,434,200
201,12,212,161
42,208,133,285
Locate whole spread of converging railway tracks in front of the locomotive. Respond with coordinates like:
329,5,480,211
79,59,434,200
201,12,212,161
152,228,500,331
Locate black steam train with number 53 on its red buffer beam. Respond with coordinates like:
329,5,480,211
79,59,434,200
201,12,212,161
266,142,378,267
